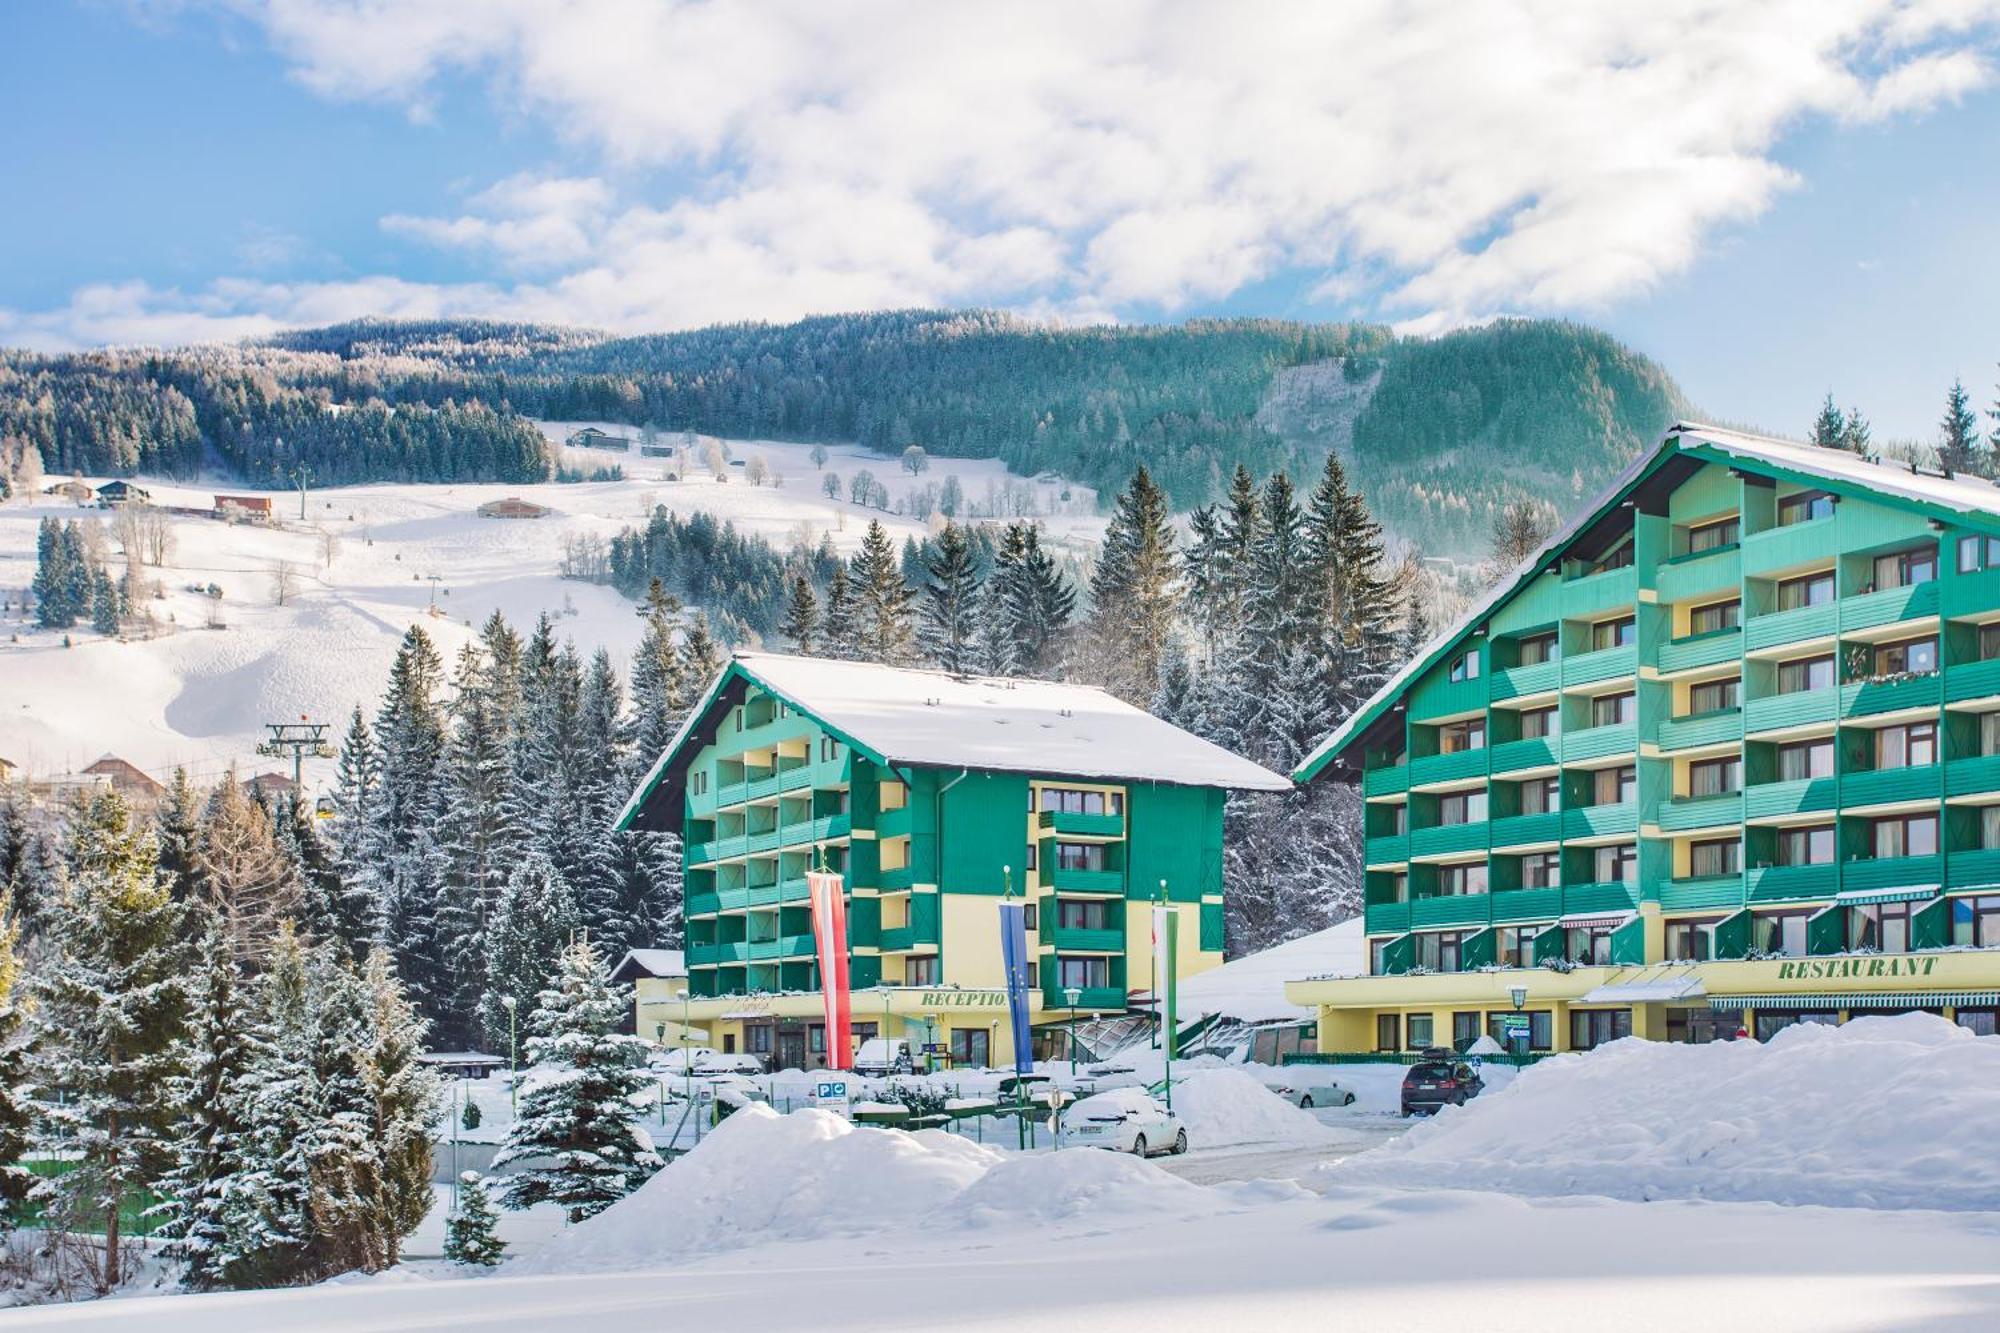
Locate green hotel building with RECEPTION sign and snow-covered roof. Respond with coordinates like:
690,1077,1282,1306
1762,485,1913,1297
620,652,1290,1069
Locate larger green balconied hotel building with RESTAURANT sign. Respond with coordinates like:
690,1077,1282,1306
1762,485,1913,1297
1286,424,2000,1053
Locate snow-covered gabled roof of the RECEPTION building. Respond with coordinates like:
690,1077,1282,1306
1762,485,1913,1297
616,652,1290,829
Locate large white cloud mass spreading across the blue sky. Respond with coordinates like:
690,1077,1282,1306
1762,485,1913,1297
12,0,2000,340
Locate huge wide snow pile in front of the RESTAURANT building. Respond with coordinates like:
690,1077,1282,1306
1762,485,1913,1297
1336,1015,2000,1209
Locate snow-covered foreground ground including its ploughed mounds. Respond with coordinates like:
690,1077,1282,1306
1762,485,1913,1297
8,1017,2000,1333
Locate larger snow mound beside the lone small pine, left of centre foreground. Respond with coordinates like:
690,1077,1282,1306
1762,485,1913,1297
508,1105,1000,1273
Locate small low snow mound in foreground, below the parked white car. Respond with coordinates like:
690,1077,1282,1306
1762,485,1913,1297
932,1149,1216,1227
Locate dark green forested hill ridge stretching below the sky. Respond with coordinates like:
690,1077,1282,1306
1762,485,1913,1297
0,310,1682,554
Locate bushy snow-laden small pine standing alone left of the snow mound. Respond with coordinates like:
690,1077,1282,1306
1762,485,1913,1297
494,937,660,1223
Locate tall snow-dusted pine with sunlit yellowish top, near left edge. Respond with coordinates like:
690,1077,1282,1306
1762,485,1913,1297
30,793,186,1293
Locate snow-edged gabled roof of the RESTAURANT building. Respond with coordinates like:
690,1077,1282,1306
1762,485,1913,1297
1292,422,2000,783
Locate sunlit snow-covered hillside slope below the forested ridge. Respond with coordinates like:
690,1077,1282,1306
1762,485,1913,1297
0,422,1102,781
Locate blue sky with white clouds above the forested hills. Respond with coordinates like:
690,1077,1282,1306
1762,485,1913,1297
0,0,2000,438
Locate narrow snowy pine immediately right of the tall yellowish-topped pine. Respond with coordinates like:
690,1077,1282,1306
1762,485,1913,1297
156,913,262,1291
